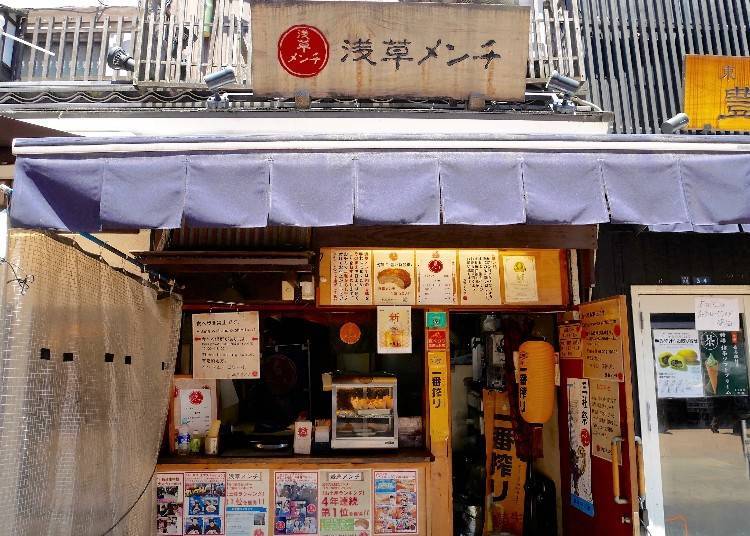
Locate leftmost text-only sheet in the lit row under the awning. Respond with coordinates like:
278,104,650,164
331,249,372,305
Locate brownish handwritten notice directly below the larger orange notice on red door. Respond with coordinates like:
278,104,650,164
589,380,622,465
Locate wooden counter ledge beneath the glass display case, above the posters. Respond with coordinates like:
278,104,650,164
158,449,434,465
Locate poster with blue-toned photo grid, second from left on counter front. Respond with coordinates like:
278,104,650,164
183,471,227,534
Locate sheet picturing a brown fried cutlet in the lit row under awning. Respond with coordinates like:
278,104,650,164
372,249,417,305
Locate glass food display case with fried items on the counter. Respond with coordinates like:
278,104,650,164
331,377,398,449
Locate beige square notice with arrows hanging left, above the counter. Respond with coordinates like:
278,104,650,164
193,311,260,380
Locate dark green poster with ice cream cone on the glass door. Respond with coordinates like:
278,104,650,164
698,331,748,397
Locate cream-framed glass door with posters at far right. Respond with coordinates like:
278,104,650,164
632,286,750,536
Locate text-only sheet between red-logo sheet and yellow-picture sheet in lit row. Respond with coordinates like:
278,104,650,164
458,249,501,305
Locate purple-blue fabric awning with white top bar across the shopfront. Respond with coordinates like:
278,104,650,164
11,132,750,232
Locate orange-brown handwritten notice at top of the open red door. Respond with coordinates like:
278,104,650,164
579,299,625,382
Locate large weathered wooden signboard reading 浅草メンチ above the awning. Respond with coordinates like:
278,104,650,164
251,2,530,100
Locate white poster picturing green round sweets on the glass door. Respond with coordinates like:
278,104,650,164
652,329,704,398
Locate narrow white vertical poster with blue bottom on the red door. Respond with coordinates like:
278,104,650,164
567,378,594,517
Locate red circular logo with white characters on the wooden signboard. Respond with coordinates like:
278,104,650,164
278,24,328,78
